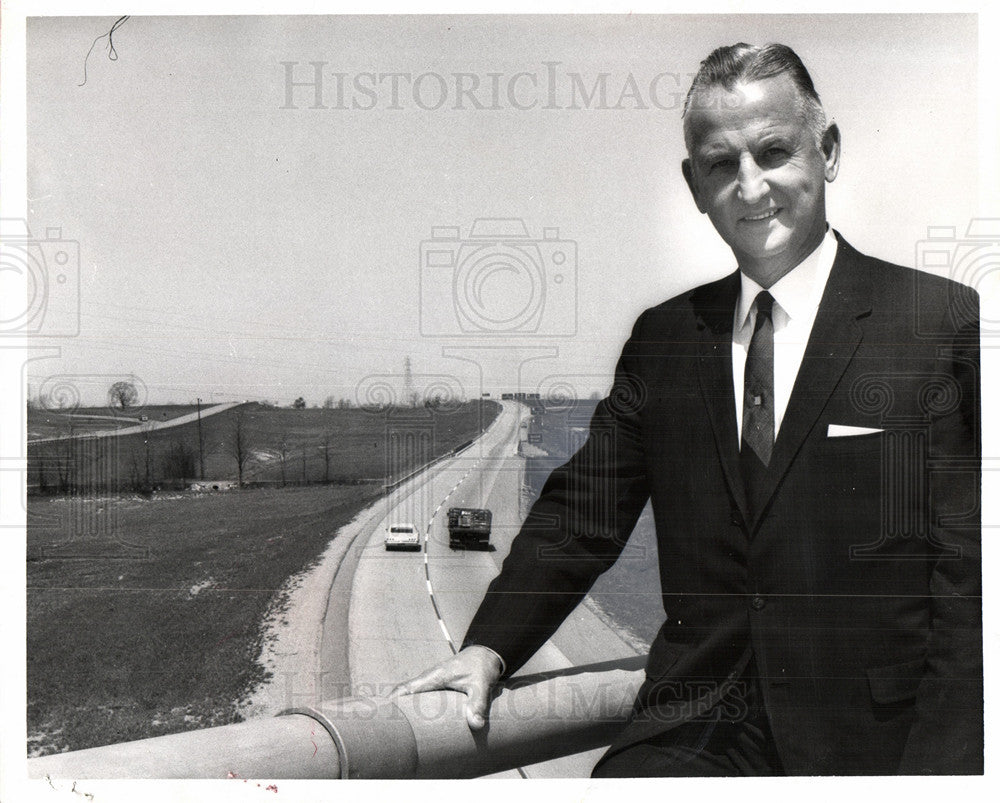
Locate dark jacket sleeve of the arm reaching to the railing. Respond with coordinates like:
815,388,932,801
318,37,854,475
462,315,649,675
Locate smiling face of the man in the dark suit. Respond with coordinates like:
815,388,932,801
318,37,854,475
683,75,840,287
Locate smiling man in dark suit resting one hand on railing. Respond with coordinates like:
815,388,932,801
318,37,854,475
401,44,983,777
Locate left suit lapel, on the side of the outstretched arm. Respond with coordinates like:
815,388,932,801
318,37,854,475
691,271,749,521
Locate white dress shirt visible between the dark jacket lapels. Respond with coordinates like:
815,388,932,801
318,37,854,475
733,227,837,443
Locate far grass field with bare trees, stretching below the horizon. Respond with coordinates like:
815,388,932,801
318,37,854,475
28,401,499,494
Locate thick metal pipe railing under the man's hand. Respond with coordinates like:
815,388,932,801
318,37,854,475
28,660,644,779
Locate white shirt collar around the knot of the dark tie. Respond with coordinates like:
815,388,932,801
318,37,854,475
735,226,837,332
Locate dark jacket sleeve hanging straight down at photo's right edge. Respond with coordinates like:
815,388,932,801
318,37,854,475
900,285,983,775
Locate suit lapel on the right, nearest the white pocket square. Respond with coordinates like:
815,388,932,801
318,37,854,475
752,235,871,532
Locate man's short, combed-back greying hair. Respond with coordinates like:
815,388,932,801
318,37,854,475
682,42,826,155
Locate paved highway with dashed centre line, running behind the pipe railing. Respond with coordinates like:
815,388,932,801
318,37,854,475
332,402,636,778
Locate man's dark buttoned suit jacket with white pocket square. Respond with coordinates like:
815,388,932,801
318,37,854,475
465,234,983,774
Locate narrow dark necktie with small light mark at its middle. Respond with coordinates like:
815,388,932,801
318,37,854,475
740,290,774,513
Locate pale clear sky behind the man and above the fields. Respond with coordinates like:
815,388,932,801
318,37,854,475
27,15,980,403
